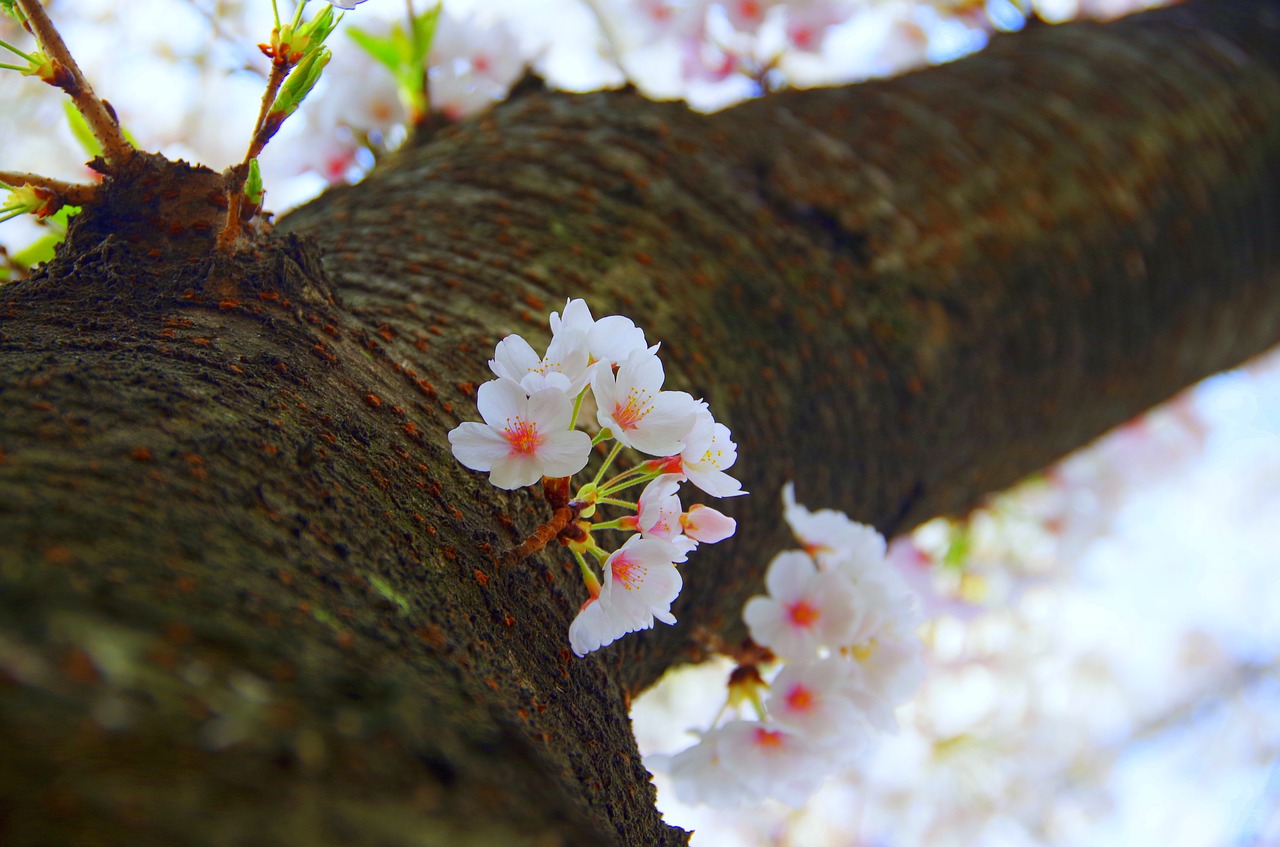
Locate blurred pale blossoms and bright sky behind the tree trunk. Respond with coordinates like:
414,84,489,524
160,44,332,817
0,0,1280,847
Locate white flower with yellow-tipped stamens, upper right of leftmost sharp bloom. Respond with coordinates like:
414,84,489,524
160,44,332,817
591,351,696,455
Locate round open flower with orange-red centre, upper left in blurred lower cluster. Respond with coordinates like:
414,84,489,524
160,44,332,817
742,550,859,661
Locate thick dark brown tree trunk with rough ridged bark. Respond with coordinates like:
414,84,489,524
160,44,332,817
0,0,1280,846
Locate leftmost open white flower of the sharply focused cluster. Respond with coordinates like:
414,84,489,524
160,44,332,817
449,379,591,490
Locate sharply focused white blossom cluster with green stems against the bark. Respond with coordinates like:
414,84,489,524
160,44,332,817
449,299,745,656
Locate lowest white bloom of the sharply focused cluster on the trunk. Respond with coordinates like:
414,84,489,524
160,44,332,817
568,535,686,656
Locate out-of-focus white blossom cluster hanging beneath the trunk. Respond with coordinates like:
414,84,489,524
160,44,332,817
649,484,923,807
